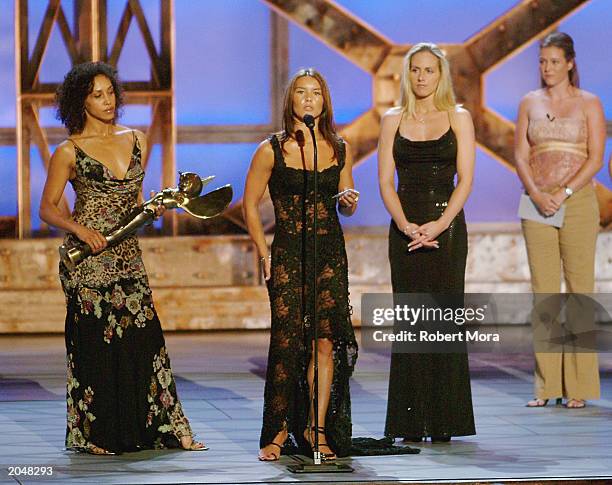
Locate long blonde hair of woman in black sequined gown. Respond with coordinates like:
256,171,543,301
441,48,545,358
400,42,457,117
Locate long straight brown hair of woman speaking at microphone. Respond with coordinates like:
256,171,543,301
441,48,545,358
280,67,339,160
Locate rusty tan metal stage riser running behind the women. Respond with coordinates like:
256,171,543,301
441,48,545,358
0,228,612,333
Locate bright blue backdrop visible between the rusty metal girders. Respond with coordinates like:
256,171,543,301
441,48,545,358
0,0,612,228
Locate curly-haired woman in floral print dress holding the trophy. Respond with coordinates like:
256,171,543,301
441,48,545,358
40,62,206,455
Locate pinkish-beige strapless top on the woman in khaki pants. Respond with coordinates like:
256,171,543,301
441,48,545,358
527,117,588,192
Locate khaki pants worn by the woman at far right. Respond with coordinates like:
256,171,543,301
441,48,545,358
522,184,600,399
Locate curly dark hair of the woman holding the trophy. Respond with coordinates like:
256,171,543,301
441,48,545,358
55,62,123,135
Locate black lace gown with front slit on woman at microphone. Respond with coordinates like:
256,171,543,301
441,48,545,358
260,135,357,456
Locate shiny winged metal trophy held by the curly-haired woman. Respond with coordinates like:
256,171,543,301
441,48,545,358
59,172,233,271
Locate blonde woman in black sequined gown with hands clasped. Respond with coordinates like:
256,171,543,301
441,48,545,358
378,43,475,442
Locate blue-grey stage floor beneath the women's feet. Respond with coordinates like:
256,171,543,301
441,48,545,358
0,331,612,484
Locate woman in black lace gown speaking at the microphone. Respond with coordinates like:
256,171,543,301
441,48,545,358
244,69,358,461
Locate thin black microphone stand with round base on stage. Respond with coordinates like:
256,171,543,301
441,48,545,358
287,120,354,473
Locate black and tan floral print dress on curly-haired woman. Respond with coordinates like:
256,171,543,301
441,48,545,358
60,131,192,452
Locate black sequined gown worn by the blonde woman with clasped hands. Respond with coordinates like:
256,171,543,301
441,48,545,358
385,122,476,437
